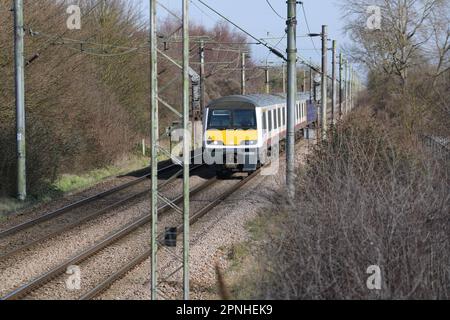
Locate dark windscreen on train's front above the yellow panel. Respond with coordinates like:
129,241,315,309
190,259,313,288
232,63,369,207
208,109,256,130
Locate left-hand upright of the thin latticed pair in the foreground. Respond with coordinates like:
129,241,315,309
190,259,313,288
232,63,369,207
150,0,159,300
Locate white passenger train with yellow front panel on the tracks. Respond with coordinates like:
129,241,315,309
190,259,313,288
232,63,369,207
203,93,317,177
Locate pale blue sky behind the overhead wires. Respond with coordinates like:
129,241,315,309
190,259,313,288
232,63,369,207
141,0,346,64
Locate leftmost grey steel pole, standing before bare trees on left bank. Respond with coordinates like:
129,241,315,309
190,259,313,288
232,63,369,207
14,0,27,201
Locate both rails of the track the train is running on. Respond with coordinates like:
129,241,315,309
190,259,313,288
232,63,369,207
2,165,259,300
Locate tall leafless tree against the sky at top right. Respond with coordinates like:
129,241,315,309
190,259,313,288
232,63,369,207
342,0,450,87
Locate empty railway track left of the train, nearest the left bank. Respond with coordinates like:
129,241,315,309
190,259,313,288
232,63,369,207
0,158,200,261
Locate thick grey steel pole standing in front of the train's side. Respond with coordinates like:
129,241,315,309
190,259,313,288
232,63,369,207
286,0,297,200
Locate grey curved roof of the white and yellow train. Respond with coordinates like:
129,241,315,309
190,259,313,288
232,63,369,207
208,92,309,108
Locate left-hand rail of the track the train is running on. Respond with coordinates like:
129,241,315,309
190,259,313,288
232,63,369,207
1,178,217,300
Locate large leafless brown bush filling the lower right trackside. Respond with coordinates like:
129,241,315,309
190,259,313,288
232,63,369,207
251,110,450,299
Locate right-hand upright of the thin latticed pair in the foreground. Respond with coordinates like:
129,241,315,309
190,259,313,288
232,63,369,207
183,0,191,300
